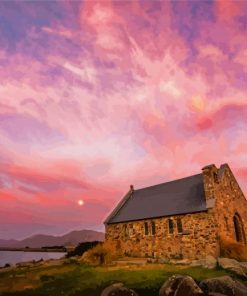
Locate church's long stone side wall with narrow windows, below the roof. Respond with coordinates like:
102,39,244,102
106,210,219,259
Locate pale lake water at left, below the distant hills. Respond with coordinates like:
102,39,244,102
0,251,66,266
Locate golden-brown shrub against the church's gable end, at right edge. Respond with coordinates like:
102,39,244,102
220,237,247,261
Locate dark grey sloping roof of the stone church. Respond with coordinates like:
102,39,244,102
105,174,207,224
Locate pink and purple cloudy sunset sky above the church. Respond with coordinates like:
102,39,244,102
0,1,247,239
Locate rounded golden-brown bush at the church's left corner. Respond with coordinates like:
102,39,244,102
82,243,117,265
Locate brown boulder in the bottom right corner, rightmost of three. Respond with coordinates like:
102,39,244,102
200,276,247,296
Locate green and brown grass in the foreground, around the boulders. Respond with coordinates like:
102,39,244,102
0,263,244,296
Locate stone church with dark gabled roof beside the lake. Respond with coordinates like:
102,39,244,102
105,164,247,259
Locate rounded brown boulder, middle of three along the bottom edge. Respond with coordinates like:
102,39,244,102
159,275,204,296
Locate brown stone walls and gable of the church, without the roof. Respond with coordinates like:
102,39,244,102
105,164,247,259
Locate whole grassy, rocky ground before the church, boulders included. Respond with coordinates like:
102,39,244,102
0,256,247,296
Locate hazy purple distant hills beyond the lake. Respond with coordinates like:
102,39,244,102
0,230,105,248
